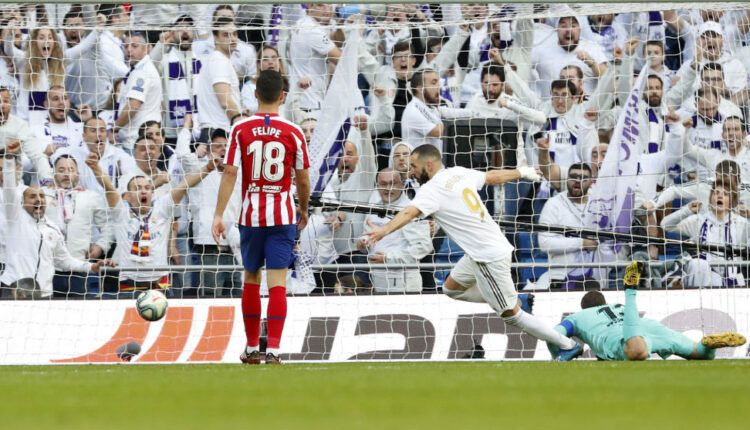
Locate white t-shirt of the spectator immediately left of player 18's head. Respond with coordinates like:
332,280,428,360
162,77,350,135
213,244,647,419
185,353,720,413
197,51,241,130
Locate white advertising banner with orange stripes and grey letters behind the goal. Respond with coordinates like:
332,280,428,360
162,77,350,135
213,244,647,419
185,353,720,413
0,289,750,364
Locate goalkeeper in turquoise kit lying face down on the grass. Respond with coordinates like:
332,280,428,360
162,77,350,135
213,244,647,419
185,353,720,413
547,261,745,361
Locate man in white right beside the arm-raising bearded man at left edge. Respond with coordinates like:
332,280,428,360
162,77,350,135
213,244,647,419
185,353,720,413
43,153,112,298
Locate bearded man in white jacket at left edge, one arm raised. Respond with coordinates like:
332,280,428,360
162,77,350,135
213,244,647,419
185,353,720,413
0,142,113,299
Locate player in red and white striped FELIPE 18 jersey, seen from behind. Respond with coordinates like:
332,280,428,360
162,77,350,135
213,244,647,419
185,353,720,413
212,70,310,364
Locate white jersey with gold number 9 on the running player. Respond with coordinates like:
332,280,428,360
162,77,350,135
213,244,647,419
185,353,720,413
410,167,513,263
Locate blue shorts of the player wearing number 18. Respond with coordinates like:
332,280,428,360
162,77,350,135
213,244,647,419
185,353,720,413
239,225,297,273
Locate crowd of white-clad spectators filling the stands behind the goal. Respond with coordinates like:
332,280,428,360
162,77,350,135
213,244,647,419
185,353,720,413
0,4,750,298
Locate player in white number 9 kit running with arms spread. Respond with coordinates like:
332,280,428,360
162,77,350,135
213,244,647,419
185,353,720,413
368,145,581,361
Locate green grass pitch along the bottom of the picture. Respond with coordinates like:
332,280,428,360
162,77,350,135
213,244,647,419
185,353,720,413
0,360,750,430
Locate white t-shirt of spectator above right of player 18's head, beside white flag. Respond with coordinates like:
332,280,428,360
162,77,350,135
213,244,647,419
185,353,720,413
289,16,336,109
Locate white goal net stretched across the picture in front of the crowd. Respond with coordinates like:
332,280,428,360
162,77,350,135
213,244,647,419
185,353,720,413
0,2,750,364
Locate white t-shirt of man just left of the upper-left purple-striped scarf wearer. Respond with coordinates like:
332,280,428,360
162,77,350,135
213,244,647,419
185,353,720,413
117,55,163,150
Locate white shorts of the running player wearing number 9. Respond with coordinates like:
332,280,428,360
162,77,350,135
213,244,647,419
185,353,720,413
451,255,518,313
